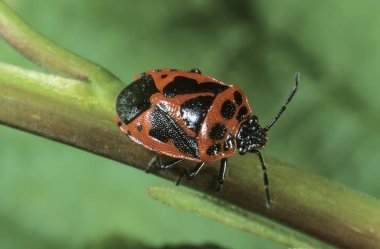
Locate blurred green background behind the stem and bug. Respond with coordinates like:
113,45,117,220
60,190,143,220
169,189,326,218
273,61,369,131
0,0,380,248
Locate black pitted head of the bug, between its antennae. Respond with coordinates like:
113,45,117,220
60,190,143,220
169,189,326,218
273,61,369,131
236,115,268,155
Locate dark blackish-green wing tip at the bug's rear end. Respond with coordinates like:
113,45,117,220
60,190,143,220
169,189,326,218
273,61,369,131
115,74,159,124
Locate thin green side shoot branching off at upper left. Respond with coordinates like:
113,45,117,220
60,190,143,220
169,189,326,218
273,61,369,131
0,0,118,84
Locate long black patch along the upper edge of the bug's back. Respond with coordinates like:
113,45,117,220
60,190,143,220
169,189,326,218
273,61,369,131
162,76,229,98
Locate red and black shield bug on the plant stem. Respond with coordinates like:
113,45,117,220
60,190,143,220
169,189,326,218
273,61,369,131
116,69,299,207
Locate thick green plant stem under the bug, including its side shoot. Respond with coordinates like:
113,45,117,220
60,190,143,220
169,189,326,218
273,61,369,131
0,1,380,248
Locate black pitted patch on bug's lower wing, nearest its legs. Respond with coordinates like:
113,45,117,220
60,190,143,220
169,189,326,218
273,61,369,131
149,106,199,158
